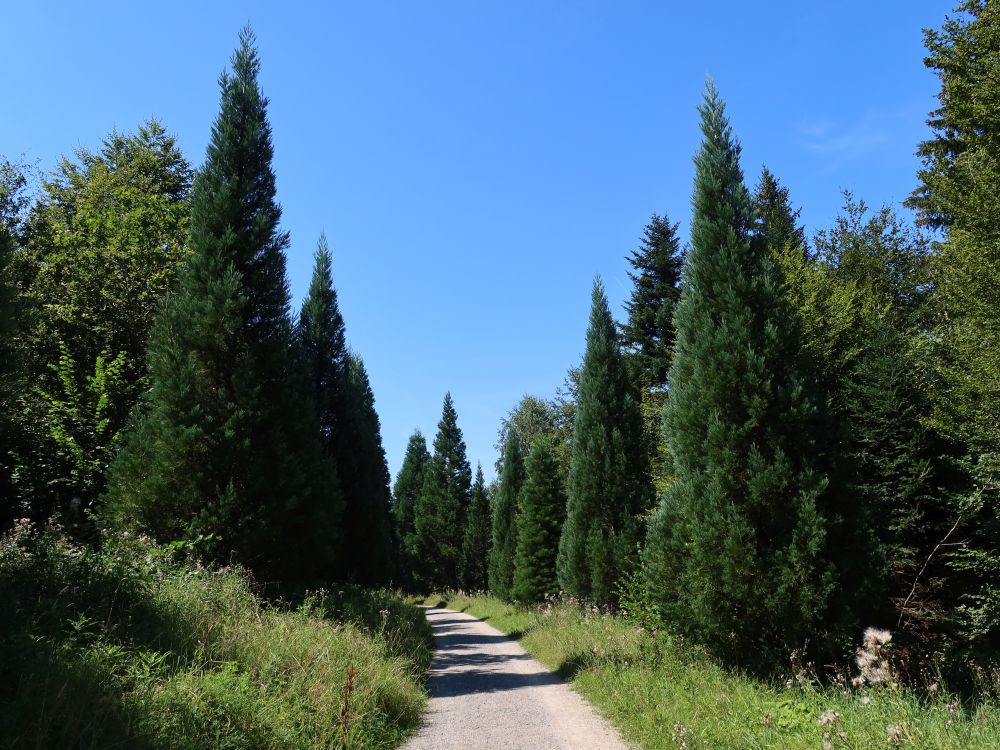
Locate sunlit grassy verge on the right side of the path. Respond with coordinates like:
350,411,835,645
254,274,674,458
428,596,1000,750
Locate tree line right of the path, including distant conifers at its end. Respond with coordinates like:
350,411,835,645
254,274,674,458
395,0,1000,674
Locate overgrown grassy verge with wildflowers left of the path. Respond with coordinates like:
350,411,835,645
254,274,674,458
0,525,432,750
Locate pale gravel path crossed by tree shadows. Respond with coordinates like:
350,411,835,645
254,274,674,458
404,607,629,750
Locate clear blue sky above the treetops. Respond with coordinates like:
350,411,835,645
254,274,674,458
0,0,952,476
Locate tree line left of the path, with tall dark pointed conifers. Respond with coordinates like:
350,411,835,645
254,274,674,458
0,28,399,591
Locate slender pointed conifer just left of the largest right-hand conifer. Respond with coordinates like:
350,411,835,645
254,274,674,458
558,279,652,603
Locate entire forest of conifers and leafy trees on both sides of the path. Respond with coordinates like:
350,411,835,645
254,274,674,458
0,0,1000,748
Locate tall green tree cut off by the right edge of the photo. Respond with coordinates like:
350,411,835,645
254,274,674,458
909,0,1000,652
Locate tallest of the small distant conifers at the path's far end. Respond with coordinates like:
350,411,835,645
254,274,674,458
414,393,472,588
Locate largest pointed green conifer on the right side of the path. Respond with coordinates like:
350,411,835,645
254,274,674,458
645,84,863,667
